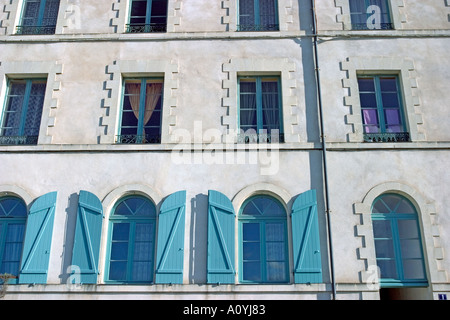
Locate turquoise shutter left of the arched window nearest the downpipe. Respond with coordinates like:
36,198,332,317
207,190,235,283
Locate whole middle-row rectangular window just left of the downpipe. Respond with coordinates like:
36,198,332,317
238,76,284,143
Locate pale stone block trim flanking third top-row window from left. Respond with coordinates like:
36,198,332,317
222,0,295,31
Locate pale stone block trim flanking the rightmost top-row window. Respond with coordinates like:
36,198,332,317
334,0,406,32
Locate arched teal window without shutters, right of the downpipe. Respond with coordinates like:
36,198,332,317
372,193,427,288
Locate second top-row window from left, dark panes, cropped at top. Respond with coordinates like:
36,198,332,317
126,0,167,33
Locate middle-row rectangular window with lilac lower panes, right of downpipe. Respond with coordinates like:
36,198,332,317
358,76,410,142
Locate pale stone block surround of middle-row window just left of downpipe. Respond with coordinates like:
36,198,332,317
222,58,299,142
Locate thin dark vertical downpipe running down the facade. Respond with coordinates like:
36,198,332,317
311,0,336,300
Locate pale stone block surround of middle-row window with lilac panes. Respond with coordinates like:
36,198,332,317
341,57,426,142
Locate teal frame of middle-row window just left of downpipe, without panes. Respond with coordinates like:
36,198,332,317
237,75,284,143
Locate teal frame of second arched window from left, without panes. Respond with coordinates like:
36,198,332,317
104,195,158,284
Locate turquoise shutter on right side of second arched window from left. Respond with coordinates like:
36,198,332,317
155,191,186,283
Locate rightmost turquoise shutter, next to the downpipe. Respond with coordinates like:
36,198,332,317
291,190,322,283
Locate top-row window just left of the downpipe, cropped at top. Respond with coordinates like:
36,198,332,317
237,0,279,31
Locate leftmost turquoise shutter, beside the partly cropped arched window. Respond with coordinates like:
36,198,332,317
19,192,57,284
